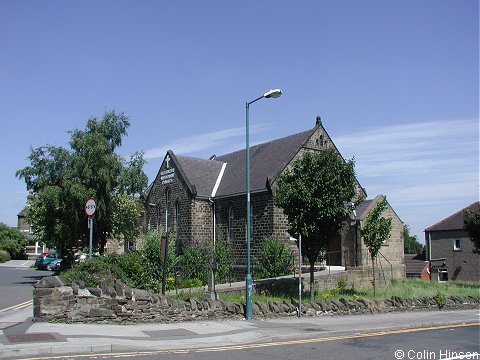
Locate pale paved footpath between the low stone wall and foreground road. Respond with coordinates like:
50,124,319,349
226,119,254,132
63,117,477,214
0,306,480,359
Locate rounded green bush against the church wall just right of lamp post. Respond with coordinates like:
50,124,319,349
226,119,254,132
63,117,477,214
254,236,293,279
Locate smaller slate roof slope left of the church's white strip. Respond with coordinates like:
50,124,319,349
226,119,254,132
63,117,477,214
175,155,223,197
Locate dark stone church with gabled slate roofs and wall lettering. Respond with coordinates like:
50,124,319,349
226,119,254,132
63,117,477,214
143,117,404,276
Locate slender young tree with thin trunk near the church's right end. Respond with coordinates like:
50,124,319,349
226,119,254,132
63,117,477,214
360,197,392,296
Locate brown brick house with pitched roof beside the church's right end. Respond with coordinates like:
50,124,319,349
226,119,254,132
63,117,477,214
425,201,480,281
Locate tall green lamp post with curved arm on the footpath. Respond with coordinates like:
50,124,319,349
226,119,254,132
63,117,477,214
245,89,282,320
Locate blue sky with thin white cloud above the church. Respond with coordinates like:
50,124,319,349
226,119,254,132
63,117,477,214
0,0,479,239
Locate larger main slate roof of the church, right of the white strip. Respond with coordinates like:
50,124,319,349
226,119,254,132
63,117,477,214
215,128,316,196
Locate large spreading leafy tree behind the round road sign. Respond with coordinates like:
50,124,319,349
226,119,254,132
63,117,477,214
16,111,147,264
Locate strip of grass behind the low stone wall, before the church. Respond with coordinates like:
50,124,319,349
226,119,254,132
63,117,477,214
172,279,480,304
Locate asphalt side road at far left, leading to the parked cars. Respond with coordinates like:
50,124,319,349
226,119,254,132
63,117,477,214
0,263,52,311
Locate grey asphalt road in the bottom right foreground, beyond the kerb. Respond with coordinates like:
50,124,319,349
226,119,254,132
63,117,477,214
26,325,480,360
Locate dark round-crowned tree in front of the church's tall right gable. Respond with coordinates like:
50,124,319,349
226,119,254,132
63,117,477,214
275,149,360,300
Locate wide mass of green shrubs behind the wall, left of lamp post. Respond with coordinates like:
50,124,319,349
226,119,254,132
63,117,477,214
62,230,231,293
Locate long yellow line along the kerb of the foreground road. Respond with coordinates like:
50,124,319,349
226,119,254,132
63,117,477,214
15,323,480,360
